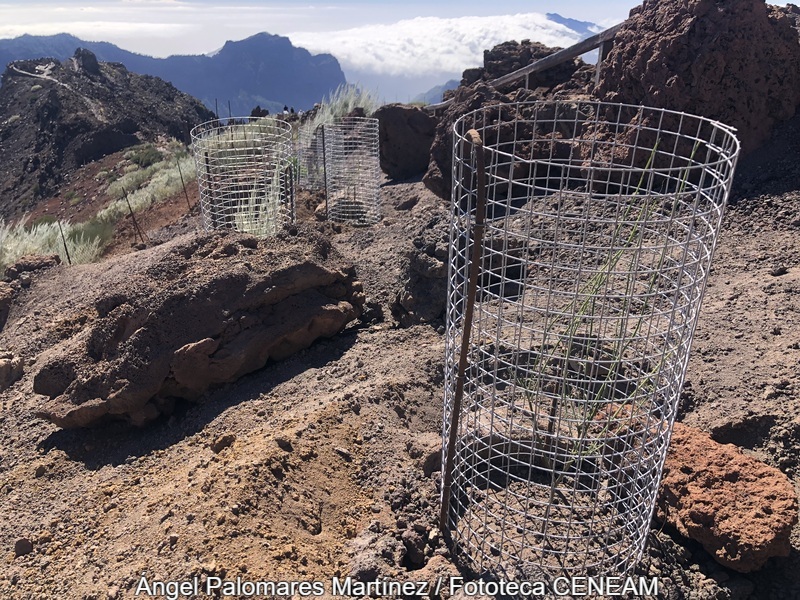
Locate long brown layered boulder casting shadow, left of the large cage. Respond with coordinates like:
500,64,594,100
33,227,364,428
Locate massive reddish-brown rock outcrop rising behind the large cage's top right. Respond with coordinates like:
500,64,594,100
595,0,800,153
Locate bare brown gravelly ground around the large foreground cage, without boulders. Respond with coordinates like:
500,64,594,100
0,101,800,600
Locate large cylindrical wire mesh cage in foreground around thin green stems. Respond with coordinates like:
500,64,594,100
442,102,739,580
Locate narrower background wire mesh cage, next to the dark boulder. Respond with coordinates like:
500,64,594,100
322,117,380,225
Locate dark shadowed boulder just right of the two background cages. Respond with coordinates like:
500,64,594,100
373,104,436,179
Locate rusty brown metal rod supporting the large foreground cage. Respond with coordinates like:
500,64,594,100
439,129,486,535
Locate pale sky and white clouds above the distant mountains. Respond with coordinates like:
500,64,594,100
0,0,638,100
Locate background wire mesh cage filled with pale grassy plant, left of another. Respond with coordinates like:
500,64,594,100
192,117,294,237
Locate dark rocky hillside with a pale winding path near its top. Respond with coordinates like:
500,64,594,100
0,50,214,218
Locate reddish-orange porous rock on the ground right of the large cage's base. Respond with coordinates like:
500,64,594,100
657,423,798,573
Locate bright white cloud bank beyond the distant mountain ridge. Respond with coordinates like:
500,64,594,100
288,13,580,76
